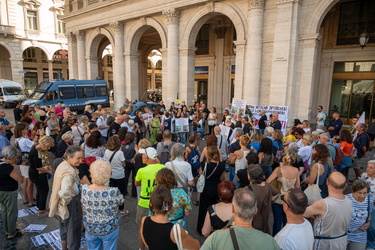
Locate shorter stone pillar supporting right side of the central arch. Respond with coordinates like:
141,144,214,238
235,41,246,101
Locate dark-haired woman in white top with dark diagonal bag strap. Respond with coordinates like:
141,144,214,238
104,136,129,216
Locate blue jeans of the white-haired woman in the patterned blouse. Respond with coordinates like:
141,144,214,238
85,228,119,250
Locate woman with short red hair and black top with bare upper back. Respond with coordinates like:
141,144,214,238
202,181,236,237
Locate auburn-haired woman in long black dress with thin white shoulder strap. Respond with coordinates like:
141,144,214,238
197,147,225,234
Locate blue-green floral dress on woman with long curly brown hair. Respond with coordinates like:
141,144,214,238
168,188,191,230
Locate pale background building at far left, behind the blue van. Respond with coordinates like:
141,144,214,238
0,0,69,93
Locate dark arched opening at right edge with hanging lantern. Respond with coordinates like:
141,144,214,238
314,0,375,123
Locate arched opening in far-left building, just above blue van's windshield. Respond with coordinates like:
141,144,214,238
22,47,51,93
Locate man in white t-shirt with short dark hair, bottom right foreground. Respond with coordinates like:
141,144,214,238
275,188,314,250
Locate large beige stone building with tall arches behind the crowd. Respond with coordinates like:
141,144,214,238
63,0,375,124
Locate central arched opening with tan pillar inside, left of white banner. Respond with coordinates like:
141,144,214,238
194,14,237,111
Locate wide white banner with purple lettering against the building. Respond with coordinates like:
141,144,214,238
247,104,289,134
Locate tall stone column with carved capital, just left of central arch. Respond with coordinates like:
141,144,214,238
163,9,180,106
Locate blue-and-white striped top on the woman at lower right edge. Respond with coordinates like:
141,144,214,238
346,194,373,243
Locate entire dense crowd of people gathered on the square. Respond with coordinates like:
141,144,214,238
0,100,375,250
